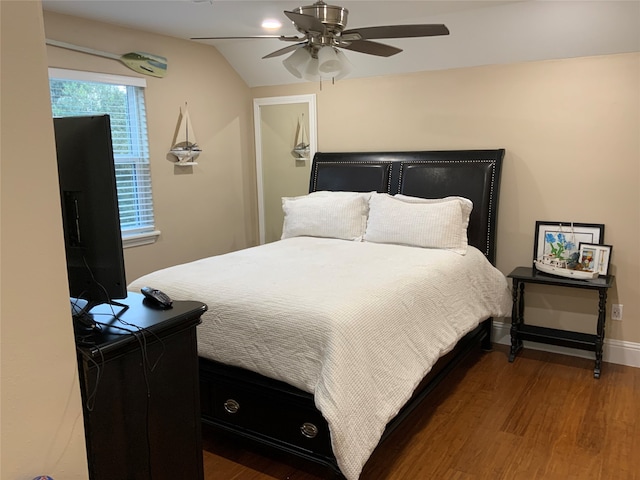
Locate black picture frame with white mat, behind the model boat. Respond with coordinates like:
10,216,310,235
533,220,604,269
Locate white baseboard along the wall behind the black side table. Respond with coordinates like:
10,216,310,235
492,322,640,368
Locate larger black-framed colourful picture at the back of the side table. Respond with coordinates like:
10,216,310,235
533,220,604,267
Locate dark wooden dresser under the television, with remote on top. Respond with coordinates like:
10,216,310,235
76,293,207,480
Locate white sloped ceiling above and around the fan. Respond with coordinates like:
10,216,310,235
42,0,640,87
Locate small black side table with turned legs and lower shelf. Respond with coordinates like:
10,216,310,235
508,267,614,378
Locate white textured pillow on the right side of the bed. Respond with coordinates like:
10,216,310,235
364,194,473,255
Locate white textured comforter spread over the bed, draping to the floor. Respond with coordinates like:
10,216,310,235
129,237,510,480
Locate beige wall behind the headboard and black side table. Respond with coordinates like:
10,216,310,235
252,53,640,343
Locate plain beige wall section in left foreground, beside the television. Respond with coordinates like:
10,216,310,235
0,1,87,480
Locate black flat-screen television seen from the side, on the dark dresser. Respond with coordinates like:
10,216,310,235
53,115,127,328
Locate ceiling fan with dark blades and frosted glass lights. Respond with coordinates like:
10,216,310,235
192,0,449,80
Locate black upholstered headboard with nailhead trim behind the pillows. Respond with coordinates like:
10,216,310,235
309,149,504,264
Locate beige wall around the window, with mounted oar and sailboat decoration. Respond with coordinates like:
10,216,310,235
44,12,258,281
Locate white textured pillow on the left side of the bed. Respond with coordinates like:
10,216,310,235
281,192,370,241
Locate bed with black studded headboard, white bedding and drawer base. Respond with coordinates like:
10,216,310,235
129,149,511,480
